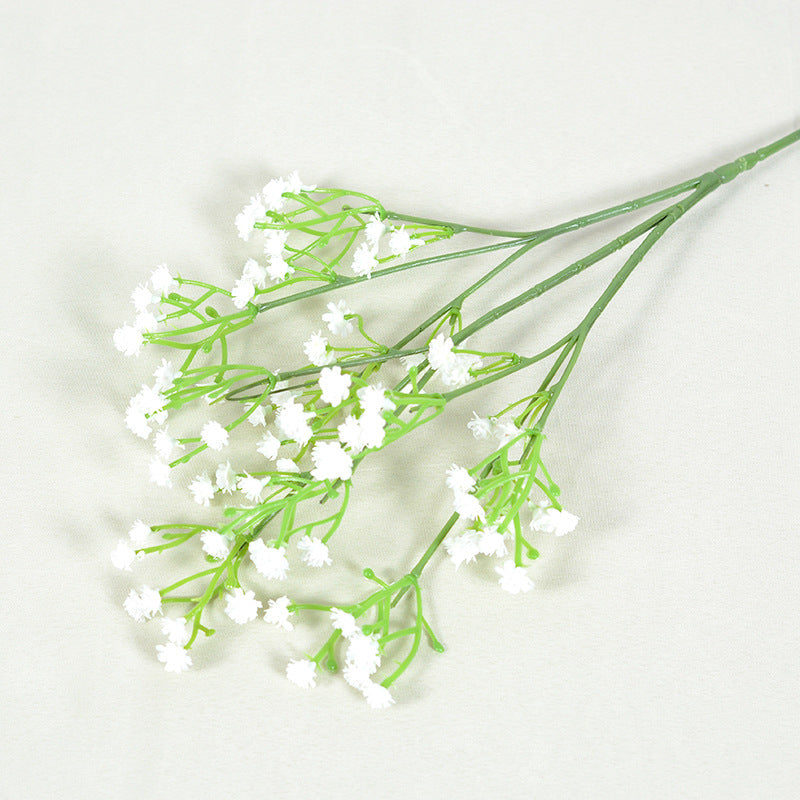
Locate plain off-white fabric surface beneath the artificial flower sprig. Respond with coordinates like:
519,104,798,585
0,0,800,800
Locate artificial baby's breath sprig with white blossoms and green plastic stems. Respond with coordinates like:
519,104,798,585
112,132,800,708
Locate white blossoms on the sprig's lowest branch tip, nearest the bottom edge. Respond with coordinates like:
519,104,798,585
284,598,394,708
